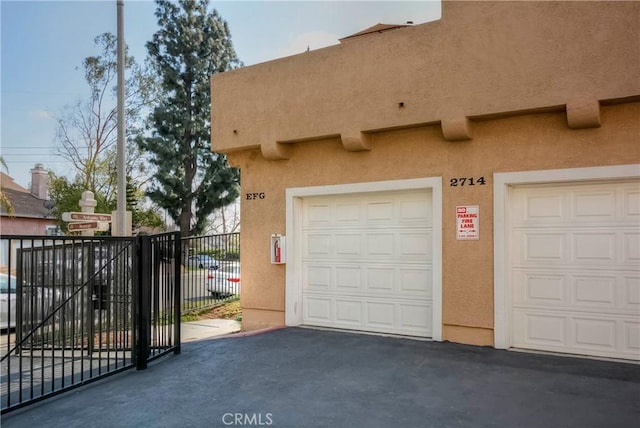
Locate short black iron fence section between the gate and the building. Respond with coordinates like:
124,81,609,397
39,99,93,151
182,233,241,314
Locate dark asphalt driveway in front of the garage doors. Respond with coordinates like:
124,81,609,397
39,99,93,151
2,328,640,428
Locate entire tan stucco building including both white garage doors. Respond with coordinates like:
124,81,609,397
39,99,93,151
212,1,640,360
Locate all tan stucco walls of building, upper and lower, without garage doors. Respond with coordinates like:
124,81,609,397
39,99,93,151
212,2,640,345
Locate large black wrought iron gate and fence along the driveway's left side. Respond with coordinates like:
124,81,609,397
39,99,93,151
0,233,181,413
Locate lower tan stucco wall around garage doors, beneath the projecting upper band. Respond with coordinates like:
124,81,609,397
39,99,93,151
229,103,640,345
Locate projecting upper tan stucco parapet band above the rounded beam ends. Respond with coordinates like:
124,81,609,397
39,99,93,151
212,1,640,159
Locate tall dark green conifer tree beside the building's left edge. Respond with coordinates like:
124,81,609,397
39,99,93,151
138,0,242,236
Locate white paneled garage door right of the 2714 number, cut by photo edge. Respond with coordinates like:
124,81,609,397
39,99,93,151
509,181,640,360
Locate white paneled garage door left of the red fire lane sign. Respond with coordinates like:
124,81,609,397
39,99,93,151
302,190,433,337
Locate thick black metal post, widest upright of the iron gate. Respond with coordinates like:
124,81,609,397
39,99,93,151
136,236,151,370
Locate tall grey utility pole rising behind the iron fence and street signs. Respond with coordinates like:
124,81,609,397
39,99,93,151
112,0,131,236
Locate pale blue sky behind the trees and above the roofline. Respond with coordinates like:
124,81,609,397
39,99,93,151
0,0,440,187
